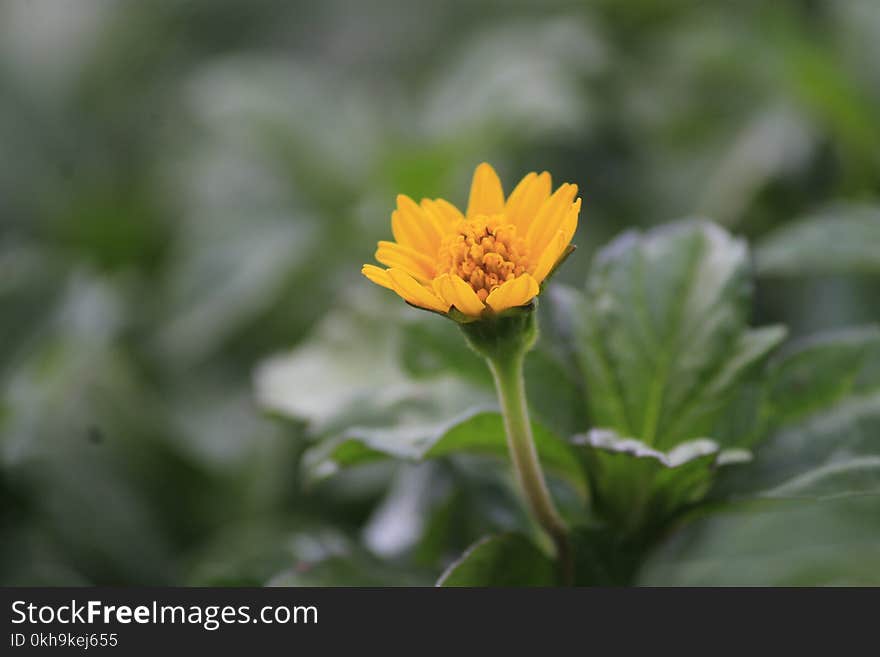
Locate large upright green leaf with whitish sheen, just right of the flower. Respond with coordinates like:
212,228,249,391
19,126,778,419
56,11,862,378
574,221,784,449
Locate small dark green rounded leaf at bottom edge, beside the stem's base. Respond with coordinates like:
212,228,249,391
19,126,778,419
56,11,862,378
437,534,557,587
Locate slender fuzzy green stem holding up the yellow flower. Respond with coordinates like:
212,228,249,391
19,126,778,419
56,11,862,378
488,350,574,586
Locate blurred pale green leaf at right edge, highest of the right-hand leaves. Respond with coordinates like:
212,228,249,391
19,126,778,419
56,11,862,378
755,205,880,276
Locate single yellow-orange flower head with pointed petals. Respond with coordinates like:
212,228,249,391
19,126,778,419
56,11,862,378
362,162,581,318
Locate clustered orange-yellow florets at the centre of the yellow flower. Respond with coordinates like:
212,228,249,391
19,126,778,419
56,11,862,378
438,214,530,301
